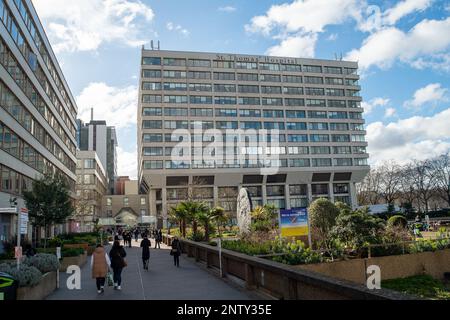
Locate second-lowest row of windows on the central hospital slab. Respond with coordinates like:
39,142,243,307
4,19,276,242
142,146,367,157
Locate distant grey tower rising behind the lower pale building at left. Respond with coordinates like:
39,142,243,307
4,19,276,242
78,120,117,194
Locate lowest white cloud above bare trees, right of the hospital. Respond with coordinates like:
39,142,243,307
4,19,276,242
367,108,450,164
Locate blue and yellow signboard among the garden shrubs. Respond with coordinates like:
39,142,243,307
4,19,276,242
280,208,309,237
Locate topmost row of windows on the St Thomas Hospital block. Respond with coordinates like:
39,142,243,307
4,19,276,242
142,57,357,75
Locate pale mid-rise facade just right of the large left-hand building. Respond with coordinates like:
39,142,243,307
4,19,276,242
75,151,108,232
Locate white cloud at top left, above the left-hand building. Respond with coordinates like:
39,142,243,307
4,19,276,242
33,0,154,53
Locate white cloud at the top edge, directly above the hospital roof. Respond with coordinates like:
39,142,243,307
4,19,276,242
245,0,363,57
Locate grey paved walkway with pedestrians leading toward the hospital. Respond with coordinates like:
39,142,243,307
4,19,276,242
47,239,255,300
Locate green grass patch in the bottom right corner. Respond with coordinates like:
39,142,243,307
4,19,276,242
381,275,450,300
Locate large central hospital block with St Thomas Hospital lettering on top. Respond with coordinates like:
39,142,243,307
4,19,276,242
138,48,369,224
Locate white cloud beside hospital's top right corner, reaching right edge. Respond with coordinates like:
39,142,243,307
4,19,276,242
345,17,450,69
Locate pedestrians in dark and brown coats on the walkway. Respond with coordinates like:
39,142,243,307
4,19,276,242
91,228,182,294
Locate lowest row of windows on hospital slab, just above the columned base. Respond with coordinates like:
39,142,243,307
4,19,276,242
143,158,368,170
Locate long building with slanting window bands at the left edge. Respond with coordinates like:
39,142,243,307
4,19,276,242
0,0,77,250
